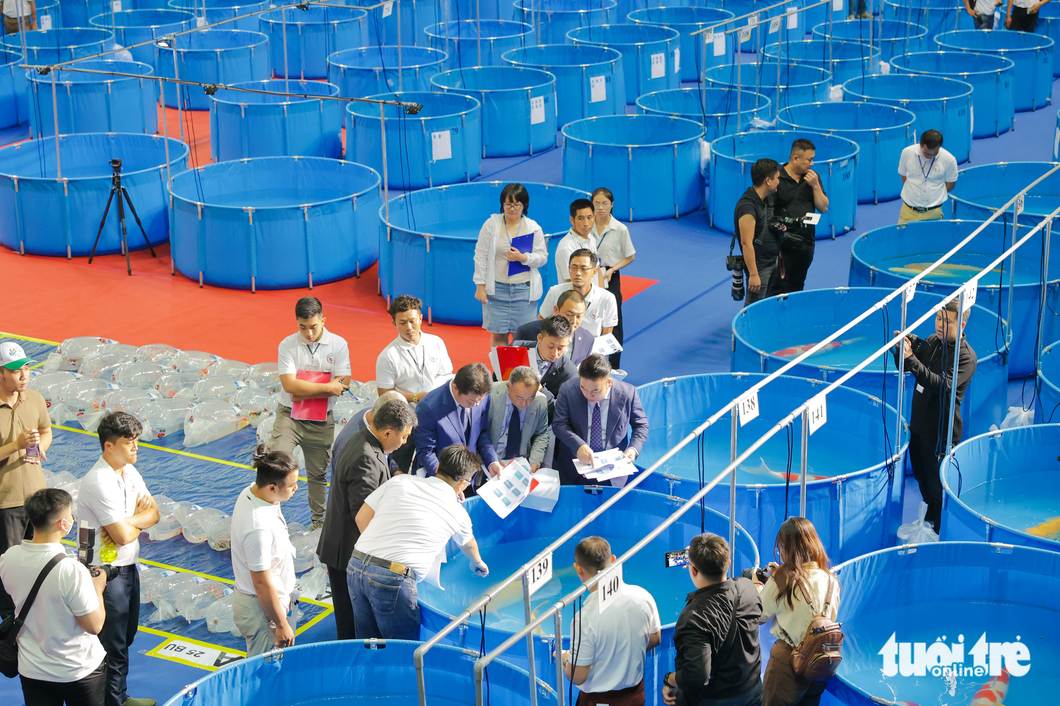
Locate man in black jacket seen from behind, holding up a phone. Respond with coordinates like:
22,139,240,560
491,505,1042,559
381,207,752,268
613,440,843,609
663,534,763,706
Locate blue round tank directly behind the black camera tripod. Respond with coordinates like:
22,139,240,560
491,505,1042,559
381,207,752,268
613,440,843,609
0,133,189,257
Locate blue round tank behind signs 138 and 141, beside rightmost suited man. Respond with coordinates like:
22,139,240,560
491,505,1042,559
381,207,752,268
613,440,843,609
637,373,907,560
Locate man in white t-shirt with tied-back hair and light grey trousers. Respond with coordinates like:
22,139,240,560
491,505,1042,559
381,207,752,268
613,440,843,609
232,444,298,657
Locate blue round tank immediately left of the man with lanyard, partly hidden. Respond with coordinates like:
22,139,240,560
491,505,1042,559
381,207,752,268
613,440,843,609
777,101,916,204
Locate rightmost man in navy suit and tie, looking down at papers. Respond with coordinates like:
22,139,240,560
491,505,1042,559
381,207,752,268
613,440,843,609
551,353,648,486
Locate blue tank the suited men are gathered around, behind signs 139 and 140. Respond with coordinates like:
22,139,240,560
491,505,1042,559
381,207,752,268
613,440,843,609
419,486,759,693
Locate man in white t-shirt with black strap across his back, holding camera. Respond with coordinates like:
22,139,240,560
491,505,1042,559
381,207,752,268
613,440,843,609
0,488,107,706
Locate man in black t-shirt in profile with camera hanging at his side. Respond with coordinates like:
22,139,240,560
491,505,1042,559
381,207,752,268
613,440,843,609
732,159,780,306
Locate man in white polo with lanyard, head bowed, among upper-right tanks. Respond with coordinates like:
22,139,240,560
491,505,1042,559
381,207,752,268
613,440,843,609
898,130,957,224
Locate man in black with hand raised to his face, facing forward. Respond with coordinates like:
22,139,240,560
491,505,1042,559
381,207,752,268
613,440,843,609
773,140,828,294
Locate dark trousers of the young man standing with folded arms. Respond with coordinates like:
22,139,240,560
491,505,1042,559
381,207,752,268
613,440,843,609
100,565,140,706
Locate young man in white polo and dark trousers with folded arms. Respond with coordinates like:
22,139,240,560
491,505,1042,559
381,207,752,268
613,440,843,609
77,411,158,706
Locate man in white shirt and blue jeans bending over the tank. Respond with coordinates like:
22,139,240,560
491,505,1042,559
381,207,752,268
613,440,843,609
346,444,490,640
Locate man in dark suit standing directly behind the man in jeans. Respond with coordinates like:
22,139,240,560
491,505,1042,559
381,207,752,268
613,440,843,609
317,400,417,640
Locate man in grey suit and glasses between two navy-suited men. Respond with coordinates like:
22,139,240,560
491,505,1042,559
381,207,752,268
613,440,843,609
490,366,550,471
